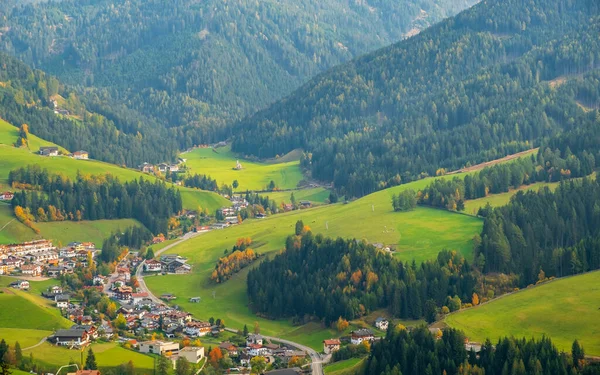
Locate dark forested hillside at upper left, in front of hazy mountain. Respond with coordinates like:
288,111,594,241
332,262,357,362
0,53,177,167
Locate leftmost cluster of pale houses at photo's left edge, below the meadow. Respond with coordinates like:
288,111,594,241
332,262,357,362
0,240,97,277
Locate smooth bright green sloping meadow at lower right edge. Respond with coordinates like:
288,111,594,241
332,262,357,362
445,271,600,356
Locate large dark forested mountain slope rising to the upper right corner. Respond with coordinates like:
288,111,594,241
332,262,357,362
233,0,600,196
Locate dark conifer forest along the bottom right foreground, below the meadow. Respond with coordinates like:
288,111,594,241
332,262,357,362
359,327,600,375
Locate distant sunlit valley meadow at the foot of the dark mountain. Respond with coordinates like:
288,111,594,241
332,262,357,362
181,147,303,191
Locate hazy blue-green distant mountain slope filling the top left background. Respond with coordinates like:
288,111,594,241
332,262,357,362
0,0,475,148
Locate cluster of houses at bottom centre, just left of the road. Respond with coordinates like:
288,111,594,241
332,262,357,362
219,334,306,367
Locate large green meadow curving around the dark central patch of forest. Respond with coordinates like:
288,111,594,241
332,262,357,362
145,173,482,350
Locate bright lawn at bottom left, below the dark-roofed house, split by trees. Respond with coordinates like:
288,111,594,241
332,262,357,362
23,342,154,374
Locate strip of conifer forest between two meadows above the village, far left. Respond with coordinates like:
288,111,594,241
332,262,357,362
9,165,182,234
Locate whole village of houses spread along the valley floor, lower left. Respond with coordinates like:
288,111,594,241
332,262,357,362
0,234,418,375
